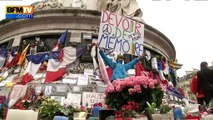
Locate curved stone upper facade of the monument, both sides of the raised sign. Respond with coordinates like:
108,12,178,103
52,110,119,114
0,0,182,69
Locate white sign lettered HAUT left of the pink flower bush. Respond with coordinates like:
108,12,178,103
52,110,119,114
82,92,104,106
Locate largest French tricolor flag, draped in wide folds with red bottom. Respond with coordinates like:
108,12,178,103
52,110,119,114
45,46,86,82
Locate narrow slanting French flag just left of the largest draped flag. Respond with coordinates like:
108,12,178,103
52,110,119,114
21,53,47,84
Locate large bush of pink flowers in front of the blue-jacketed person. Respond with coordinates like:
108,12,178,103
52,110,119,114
105,75,163,116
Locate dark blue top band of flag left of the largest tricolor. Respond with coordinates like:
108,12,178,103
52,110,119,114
27,53,47,64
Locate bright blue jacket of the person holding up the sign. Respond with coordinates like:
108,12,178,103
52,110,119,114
100,50,138,80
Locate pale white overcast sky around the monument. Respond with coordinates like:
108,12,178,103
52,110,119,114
0,0,213,76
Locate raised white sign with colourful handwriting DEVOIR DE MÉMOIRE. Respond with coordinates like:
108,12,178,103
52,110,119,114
98,11,144,56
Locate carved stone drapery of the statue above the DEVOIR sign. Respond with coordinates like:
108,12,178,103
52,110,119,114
98,0,143,18
